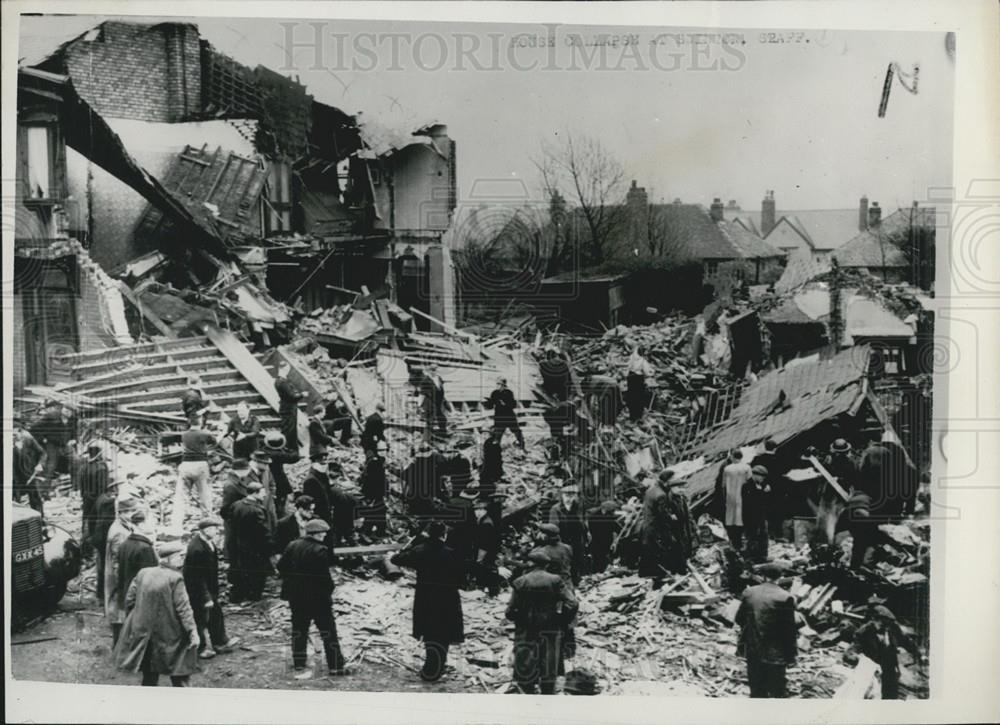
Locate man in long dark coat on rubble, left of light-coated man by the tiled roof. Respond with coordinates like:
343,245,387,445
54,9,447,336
639,470,697,587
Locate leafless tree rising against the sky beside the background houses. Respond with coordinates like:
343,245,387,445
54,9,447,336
535,134,627,264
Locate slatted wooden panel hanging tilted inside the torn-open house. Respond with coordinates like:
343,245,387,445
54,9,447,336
135,145,267,247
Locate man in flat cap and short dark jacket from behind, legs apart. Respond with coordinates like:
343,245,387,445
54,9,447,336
278,518,347,675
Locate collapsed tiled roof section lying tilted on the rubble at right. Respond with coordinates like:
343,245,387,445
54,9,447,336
698,345,871,458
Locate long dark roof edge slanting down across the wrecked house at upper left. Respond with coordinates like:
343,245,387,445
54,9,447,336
18,68,229,258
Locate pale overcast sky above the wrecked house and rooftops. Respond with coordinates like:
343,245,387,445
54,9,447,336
22,17,954,210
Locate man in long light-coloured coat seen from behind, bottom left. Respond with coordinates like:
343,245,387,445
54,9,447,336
115,542,201,687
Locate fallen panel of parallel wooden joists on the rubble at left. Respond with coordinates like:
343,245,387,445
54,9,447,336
59,331,279,429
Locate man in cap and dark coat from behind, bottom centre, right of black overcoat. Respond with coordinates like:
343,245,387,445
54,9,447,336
507,549,577,695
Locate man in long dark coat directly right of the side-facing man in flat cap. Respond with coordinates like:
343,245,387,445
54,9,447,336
229,481,274,603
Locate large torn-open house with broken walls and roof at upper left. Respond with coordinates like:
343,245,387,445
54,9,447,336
14,21,456,396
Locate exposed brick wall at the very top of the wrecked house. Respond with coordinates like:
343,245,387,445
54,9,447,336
66,22,201,123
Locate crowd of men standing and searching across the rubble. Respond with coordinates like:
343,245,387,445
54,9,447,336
14,348,917,697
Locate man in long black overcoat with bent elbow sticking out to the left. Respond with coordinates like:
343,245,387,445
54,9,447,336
390,521,466,682
